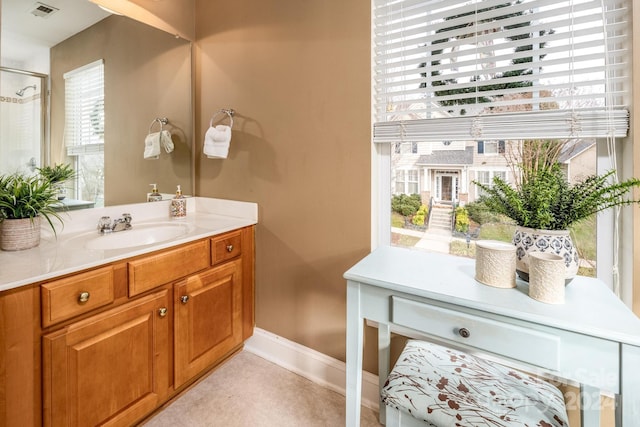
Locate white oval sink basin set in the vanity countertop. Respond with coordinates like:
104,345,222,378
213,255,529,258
75,222,191,250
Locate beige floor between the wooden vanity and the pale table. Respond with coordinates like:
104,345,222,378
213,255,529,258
143,351,380,427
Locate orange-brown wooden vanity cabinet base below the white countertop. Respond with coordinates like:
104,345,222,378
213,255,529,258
0,226,254,427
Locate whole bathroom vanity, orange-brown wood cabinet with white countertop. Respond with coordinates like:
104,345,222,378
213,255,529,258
0,198,257,426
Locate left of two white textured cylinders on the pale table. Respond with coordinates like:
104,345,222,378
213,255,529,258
476,240,516,288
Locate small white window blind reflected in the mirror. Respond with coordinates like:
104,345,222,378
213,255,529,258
64,60,104,155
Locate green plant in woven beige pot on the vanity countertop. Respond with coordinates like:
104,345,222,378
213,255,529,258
0,173,62,251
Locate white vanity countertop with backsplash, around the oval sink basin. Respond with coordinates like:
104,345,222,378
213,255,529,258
0,197,258,291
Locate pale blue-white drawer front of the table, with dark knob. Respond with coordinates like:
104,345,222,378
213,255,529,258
391,296,561,370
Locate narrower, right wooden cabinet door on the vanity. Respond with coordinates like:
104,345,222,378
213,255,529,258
174,259,242,387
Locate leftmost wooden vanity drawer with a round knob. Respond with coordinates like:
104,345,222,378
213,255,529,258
40,266,114,327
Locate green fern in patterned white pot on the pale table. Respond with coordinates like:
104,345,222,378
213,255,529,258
475,163,640,283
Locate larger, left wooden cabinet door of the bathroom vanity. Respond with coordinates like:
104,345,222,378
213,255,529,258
43,289,171,426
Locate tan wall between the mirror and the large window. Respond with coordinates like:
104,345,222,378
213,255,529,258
196,0,371,360
